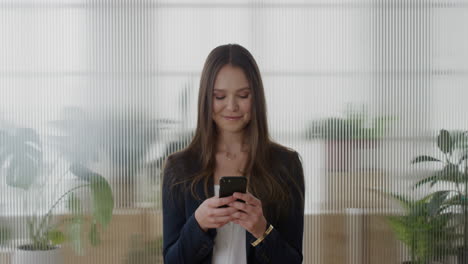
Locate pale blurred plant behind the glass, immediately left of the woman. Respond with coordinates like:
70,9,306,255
48,107,177,207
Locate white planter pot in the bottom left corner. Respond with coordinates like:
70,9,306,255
11,246,64,264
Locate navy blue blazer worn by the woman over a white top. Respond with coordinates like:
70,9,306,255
162,146,304,264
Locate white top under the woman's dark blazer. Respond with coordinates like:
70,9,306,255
211,185,247,264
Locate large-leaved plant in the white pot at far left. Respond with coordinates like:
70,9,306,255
0,128,114,263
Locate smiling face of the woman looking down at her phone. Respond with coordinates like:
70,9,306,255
213,64,252,133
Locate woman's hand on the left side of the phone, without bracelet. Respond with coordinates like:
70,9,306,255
195,195,238,232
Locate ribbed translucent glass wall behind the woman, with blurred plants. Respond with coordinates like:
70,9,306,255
0,0,468,264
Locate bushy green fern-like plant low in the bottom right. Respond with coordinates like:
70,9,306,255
387,193,459,264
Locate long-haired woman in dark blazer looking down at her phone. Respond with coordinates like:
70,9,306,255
163,44,304,264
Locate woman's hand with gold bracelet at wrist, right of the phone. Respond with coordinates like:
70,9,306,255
228,192,267,238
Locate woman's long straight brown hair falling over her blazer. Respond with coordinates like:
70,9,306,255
170,44,303,220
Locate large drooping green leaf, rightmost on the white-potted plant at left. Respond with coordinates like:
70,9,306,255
70,163,114,228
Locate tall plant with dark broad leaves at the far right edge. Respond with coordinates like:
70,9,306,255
412,129,468,263
